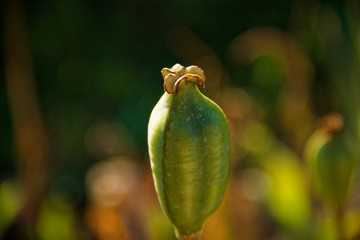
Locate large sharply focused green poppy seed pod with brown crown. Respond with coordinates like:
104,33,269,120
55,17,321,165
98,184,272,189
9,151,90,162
148,64,230,239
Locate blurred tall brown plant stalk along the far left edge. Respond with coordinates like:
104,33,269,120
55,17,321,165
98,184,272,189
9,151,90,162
3,0,49,234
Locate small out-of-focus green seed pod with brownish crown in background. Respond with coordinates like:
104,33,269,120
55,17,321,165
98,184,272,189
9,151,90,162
304,114,359,205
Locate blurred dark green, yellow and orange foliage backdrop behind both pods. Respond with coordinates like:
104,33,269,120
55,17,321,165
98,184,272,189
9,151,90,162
0,0,360,240
